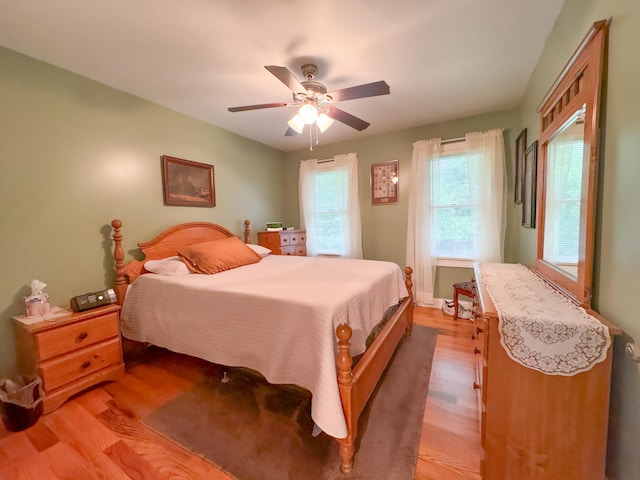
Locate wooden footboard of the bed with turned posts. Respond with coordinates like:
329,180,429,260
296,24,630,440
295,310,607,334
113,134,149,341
336,267,413,473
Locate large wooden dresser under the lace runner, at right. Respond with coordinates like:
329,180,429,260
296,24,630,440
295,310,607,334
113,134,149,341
473,265,621,480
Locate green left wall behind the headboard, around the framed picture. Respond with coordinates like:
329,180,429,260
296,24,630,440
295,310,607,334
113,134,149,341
0,48,284,378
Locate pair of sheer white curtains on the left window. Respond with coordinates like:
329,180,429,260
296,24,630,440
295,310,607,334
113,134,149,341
298,153,362,258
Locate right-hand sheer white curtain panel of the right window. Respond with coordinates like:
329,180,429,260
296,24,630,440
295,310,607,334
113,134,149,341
465,129,506,263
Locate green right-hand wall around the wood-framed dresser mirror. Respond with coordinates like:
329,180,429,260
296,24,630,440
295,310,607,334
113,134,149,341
518,0,640,480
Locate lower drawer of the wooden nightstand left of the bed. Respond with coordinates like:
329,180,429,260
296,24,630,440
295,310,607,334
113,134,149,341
39,337,122,395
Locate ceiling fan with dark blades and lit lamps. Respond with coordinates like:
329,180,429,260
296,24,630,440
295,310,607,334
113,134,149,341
228,63,390,136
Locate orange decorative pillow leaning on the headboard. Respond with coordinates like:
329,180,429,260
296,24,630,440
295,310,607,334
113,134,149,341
178,237,262,274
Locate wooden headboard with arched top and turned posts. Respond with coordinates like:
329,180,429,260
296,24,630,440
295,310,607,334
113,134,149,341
111,219,251,305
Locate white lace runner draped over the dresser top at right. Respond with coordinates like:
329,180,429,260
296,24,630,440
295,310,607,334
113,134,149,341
480,263,611,376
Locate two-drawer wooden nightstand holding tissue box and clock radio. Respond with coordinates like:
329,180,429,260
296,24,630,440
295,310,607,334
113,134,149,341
12,305,124,413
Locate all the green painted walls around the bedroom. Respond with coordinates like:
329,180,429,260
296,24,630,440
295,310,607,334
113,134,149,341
5,0,640,480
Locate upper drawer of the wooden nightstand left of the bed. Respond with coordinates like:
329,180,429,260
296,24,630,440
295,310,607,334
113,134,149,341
35,312,120,360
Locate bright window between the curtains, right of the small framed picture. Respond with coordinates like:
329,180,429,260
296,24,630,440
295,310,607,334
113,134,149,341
430,142,478,260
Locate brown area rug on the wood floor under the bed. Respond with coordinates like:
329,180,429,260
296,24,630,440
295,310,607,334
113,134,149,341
143,325,437,480
